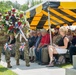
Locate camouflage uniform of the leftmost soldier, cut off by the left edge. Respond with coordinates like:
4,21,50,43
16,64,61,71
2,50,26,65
0,31,12,68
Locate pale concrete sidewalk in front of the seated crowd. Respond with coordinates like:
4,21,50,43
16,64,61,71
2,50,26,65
0,55,65,75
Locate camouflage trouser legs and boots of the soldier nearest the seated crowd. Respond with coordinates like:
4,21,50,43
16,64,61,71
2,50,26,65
15,36,30,67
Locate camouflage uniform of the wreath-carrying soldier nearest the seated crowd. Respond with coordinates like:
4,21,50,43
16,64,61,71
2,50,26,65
15,23,30,66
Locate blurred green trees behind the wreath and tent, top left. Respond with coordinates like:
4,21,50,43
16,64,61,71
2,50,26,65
0,0,42,13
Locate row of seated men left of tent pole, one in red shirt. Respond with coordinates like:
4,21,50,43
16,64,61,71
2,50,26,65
28,29,50,62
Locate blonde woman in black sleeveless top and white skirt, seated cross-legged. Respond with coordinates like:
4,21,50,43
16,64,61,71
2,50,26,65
48,26,70,67
